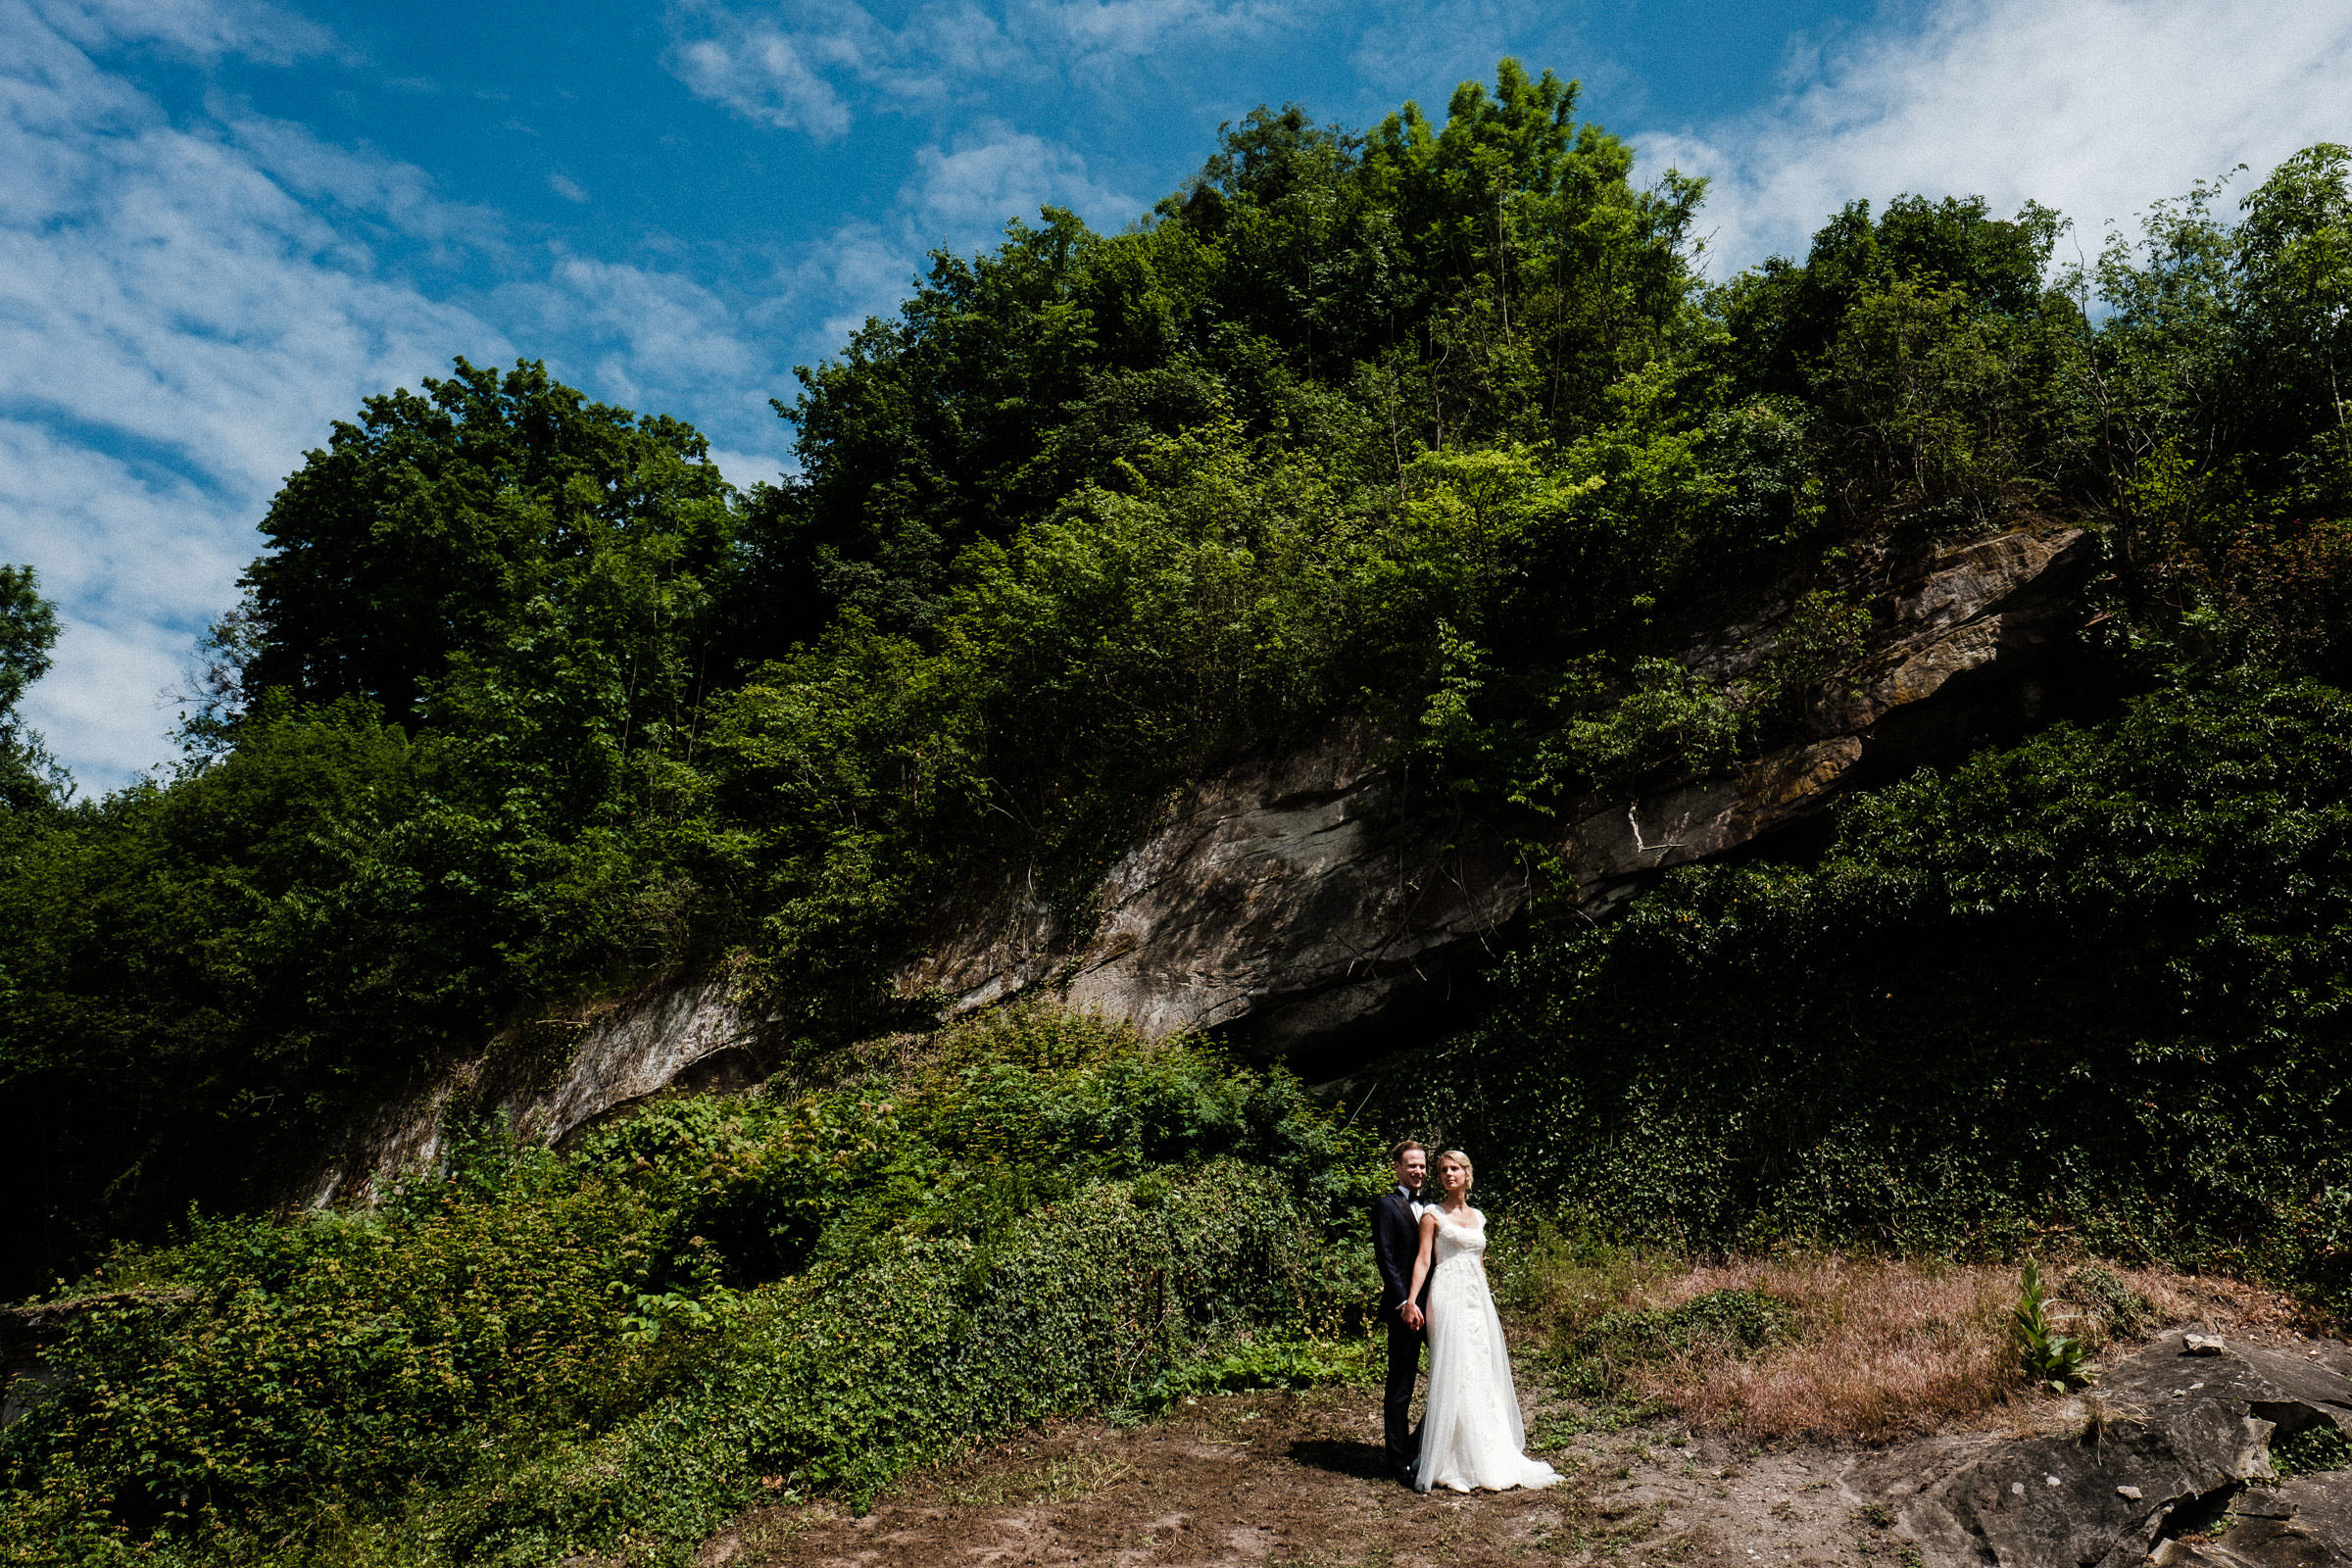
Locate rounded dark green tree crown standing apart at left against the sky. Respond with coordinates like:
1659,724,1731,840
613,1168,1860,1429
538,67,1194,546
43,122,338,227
240,360,734,721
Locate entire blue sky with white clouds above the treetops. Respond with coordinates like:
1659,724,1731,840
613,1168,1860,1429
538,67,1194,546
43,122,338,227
0,0,2352,792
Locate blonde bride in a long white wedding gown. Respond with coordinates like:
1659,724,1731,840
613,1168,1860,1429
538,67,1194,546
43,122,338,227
1406,1150,1559,1493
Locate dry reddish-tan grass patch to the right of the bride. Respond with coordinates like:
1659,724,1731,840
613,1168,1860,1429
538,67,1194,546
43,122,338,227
1519,1253,2293,1444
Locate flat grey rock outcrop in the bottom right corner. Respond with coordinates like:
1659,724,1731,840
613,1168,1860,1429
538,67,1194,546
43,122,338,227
1848,1331,2352,1568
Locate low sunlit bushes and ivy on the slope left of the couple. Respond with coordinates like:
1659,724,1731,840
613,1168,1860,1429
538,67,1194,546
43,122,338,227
0,1015,1378,1566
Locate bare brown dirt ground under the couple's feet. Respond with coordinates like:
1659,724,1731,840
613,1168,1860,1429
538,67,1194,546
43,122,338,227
699,1387,1905,1568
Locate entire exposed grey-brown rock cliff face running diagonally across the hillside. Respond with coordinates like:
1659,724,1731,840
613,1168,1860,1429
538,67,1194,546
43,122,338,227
301,524,2093,1203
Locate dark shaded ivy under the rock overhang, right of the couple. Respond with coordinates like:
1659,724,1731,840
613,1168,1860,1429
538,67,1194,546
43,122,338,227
1386,672,2352,1304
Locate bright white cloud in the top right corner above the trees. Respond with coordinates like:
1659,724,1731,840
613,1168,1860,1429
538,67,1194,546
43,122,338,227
1635,0,2352,275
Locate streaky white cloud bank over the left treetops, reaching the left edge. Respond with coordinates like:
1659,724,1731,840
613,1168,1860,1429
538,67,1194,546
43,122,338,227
0,0,818,790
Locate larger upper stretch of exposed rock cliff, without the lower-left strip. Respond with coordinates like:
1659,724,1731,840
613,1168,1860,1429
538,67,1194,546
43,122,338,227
899,526,2093,1054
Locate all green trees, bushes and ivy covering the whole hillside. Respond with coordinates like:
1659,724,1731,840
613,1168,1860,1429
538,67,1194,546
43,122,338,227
0,61,2352,1563
